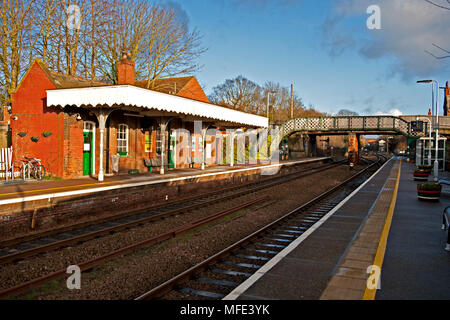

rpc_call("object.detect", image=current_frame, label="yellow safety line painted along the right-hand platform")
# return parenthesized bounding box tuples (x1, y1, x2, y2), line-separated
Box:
(362, 160, 402, 300)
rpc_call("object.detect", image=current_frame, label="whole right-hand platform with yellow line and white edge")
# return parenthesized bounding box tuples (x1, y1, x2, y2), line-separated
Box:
(225, 158, 450, 300)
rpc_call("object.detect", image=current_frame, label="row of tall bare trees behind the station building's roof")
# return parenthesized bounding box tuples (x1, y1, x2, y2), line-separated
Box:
(0, 0, 205, 105)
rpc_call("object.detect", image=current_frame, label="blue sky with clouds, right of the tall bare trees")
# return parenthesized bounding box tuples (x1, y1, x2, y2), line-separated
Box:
(162, 0, 450, 115)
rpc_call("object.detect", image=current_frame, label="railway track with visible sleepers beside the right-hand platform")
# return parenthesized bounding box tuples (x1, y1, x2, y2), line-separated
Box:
(137, 159, 382, 300)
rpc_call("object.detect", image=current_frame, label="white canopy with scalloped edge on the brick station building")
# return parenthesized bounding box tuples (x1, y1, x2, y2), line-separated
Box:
(47, 85, 269, 128)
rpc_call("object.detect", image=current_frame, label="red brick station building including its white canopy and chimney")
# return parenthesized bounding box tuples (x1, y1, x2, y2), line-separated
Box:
(11, 56, 268, 181)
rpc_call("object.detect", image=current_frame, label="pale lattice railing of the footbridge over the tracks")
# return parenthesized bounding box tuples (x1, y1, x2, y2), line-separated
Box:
(281, 116, 411, 137)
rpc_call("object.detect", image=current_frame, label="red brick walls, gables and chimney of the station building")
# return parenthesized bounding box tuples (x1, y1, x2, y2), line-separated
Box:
(11, 62, 223, 178)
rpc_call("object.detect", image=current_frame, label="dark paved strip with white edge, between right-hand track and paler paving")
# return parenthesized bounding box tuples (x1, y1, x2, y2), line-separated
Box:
(225, 161, 395, 300)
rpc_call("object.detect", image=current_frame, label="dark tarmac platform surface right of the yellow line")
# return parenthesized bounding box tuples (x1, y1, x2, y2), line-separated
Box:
(376, 163, 450, 300)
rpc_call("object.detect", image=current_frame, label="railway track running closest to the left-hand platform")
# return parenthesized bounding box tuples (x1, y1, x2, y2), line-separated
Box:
(0, 161, 343, 265)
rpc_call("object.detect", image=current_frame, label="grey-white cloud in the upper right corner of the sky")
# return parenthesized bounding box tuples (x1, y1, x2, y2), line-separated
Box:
(322, 0, 450, 79)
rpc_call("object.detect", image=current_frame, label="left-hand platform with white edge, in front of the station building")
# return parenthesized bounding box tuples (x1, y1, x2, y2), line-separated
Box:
(0, 157, 331, 237)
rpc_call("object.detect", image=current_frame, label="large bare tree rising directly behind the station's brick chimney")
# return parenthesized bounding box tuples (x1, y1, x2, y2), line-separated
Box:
(100, 0, 205, 85)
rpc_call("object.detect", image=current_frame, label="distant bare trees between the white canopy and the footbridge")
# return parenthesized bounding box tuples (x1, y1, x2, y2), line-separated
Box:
(208, 76, 323, 122)
